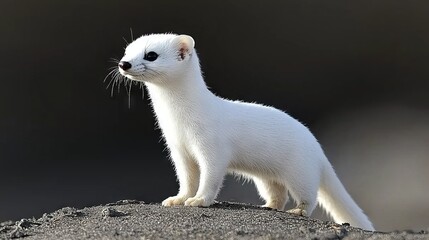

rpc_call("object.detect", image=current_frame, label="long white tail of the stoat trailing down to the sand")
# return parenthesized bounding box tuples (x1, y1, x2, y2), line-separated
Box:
(318, 162, 374, 231)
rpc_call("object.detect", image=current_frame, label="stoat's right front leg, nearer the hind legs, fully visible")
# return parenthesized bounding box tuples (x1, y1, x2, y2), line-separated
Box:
(185, 151, 228, 207)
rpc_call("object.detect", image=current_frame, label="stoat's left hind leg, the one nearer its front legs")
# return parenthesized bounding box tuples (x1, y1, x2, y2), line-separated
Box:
(253, 177, 288, 211)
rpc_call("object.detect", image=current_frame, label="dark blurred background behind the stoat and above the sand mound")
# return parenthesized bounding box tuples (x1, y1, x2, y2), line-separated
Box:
(0, 0, 429, 230)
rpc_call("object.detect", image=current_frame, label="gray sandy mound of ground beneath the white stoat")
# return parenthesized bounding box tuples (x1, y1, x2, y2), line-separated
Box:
(0, 200, 429, 240)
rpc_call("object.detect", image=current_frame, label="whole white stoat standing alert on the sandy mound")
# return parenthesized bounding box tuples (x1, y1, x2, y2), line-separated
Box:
(115, 34, 374, 230)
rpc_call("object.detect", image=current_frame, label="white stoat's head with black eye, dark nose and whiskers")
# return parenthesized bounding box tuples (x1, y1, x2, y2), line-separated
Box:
(118, 34, 195, 83)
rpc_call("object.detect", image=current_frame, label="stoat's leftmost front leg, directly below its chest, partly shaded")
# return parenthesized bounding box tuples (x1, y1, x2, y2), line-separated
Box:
(162, 149, 200, 206)
